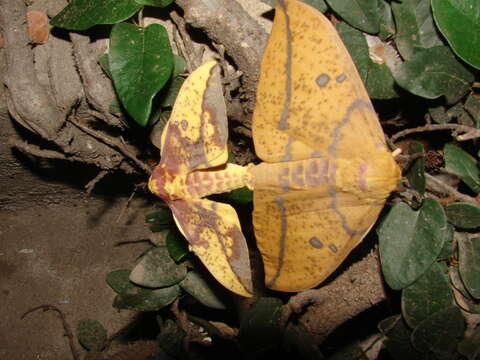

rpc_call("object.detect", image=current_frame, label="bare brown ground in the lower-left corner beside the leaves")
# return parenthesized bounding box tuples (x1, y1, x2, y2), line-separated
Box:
(0, 199, 156, 360)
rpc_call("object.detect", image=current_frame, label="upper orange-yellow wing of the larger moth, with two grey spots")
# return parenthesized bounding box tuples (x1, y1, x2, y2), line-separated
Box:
(253, 0, 385, 162)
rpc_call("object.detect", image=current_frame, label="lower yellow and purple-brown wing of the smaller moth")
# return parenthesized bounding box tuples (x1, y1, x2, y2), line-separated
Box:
(169, 199, 253, 297)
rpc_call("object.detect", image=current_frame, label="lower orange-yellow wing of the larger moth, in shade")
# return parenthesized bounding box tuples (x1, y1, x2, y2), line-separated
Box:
(253, 189, 383, 292)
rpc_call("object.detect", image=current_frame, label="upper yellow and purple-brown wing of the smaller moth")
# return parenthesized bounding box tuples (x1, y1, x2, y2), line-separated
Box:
(160, 61, 228, 174)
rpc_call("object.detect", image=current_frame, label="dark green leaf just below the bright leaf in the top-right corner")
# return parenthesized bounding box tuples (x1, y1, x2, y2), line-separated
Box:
(393, 46, 474, 104)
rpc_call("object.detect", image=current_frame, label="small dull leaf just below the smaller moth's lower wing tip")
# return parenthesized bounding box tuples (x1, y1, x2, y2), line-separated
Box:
(179, 271, 227, 309)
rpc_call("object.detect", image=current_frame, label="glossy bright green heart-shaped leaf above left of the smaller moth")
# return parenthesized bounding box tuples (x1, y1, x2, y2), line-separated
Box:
(108, 23, 173, 126)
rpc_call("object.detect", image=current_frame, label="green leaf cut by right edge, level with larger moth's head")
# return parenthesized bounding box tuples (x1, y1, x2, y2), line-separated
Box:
(443, 144, 480, 193)
